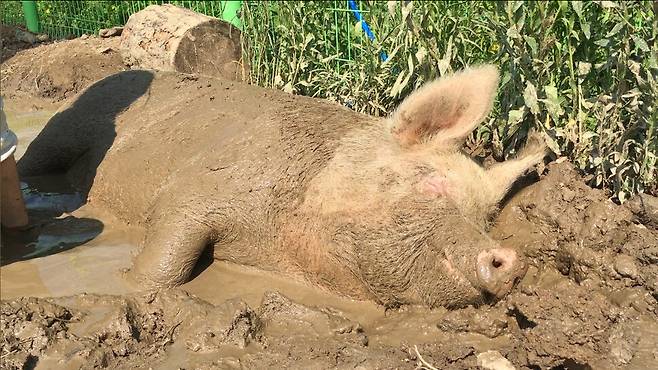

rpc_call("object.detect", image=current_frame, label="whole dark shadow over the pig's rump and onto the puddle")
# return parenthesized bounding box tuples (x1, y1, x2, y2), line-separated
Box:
(0, 71, 153, 265)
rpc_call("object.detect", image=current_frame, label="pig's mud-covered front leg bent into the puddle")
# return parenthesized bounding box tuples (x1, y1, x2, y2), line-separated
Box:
(130, 209, 213, 289)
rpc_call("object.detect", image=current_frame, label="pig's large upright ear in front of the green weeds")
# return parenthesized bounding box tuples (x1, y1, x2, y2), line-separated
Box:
(384, 65, 498, 147)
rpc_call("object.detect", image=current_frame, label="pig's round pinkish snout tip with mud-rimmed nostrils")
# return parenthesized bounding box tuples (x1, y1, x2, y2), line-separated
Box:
(477, 248, 528, 298)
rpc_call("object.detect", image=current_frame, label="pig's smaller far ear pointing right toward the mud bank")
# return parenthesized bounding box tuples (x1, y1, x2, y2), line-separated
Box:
(485, 134, 547, 206)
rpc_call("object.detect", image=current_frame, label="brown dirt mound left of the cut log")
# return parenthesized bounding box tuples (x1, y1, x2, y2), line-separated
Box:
(0, 37, 126, 102)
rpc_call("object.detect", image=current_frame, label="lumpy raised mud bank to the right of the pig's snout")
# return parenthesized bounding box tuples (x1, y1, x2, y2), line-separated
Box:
(491, 162, 658, 298)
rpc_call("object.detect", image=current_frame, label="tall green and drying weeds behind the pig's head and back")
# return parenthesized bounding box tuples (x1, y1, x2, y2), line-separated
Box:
(243, 1, 658, 202)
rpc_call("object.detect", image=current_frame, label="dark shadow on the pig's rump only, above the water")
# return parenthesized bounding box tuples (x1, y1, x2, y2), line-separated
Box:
(18, 71, 153, 199)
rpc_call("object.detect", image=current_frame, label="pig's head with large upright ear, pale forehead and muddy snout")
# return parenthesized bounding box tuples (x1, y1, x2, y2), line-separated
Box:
(307, 66, 527, 307)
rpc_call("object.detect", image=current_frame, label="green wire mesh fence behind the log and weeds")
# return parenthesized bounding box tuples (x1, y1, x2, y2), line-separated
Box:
(0, 0, 364, 72)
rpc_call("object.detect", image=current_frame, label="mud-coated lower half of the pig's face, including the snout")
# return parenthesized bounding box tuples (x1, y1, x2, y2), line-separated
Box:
(334, 194, 527, 307)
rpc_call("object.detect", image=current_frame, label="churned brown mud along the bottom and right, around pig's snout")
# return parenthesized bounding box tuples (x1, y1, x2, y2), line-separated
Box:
(0, 162, 658, 369)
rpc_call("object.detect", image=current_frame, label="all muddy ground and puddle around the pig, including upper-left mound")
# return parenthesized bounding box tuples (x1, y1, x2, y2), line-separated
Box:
(0, 38, 658, 369)
